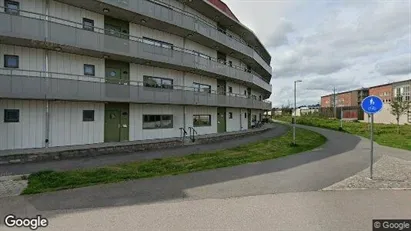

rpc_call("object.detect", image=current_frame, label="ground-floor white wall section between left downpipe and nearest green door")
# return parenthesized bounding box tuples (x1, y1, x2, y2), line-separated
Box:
(50, 101, 104, 146)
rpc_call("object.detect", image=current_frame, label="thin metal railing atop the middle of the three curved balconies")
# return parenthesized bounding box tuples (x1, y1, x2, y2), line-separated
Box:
(0, 7, 271, 92)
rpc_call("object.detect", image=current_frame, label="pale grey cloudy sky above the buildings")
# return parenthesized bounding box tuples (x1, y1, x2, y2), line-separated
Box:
(224, 0, 411, 107)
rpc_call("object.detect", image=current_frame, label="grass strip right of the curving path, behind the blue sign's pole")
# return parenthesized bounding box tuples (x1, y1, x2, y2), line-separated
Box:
(275, 116, 411, 150)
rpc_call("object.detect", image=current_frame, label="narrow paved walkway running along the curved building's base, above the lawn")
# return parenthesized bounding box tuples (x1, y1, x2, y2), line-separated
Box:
(0, 124, 288, 176)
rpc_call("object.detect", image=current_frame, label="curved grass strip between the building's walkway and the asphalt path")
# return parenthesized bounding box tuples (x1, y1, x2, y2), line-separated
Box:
(23, 129, 326, 194)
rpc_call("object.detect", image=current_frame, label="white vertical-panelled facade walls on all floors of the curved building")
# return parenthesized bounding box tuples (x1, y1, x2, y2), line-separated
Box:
(0, 0, 272, 150)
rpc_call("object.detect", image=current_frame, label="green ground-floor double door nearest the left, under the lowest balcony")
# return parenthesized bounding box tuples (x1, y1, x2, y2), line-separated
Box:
(104, 103, 129, 142)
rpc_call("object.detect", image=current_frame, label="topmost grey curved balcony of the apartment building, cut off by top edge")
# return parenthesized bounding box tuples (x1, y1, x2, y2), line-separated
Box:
(54, 0, 272, 78)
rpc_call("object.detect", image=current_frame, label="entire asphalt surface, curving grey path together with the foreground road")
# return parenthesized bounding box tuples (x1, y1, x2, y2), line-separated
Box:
(0, 126, 411, 230)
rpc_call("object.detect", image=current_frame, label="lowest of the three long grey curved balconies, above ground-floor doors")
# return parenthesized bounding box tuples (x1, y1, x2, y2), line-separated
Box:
(0, 69, 271, 110)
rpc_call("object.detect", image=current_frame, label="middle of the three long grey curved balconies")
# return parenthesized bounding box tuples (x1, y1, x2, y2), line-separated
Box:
(0, 11, 271, 97)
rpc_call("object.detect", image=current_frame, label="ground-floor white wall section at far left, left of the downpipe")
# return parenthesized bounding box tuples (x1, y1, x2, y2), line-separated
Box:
(0, 99, 46, 150)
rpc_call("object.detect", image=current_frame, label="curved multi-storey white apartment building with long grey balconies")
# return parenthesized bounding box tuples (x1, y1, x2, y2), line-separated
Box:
(0, 0, 272, 150)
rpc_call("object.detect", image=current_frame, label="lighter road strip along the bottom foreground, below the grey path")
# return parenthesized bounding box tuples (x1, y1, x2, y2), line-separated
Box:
(0, 190, 411, 231)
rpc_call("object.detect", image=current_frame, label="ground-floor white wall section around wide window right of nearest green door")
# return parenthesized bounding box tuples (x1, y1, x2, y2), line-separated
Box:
(129, 104, 184, 140)
